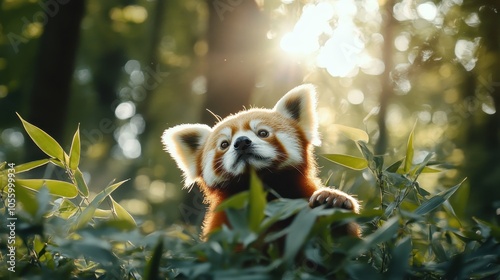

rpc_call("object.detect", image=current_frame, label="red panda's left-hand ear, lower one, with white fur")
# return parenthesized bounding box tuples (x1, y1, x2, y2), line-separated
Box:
(161, 124, 212, 187)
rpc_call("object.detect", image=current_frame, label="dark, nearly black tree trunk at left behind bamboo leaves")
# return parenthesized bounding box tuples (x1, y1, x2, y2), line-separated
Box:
(27, 0, 85, 160)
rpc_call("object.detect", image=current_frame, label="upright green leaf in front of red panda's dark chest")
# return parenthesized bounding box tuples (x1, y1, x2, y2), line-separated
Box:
(248, 169, 267, 232)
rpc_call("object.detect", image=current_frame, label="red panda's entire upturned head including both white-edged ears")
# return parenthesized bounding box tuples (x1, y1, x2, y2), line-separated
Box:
(162, 85, 319, 187)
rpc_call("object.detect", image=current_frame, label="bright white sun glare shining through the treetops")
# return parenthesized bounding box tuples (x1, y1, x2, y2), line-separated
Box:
(280, 0, 378, 77)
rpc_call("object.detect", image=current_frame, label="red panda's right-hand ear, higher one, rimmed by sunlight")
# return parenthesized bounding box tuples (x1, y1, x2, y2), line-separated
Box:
(274, 84, 321, 145)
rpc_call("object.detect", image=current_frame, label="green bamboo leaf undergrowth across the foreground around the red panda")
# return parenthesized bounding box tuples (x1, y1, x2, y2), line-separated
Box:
(0, 115, 500, 279)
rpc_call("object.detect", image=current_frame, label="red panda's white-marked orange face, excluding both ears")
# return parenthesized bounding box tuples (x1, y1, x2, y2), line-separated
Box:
(200, 109, 308, 186)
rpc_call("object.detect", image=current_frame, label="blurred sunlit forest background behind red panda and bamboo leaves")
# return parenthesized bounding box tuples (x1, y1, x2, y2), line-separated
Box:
(0, 0, 500, 231)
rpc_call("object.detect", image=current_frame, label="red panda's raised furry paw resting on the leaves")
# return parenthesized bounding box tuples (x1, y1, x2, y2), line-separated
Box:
(309, 188, 359, 213)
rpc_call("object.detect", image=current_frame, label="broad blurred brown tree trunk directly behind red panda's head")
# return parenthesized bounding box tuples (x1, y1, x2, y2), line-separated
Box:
(202, 0, 266, 124)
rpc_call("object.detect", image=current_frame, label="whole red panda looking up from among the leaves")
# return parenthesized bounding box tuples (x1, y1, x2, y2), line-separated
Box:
(162, 85, 360, 237)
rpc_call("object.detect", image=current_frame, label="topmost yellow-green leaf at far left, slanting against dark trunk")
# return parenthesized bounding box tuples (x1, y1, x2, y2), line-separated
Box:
(17, 114, 65, 162)
